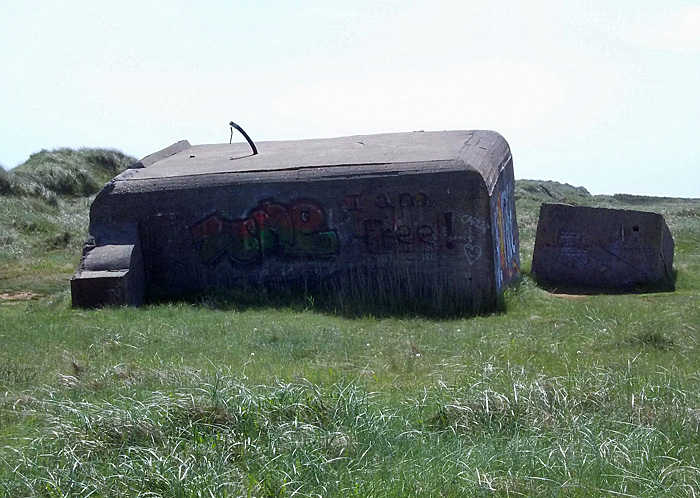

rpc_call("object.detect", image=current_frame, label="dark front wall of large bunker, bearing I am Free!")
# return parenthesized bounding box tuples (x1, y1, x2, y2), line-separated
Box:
(85, 164, 500, 313)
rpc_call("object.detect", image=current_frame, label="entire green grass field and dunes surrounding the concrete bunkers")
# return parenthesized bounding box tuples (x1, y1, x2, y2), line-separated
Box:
(0, 149, 700, 497)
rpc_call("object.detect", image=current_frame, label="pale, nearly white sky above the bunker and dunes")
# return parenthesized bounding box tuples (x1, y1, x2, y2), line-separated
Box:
(0, 0, 700, 197)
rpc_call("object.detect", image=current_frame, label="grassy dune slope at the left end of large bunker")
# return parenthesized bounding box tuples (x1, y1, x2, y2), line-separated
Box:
(0, 149, 136, 294)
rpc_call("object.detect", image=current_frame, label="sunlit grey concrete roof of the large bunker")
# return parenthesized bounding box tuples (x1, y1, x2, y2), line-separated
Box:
(116, 130, 511, 193)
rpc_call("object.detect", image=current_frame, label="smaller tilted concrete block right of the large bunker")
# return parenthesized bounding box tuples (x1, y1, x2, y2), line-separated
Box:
(532, 204, 674, 290)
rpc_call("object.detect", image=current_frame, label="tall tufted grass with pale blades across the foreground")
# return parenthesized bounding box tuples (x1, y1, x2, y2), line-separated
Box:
(5, 367, 700, 497)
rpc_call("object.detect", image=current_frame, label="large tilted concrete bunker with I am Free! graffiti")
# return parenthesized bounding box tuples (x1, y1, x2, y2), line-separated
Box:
(72, 131, 519, 314)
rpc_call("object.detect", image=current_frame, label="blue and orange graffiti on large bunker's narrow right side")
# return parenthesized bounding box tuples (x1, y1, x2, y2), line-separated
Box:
(492, 178, 520, 290)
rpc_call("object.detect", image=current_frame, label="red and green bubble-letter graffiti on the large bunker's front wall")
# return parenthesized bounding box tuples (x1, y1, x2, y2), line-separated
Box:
(190, 199, 339, 264)
